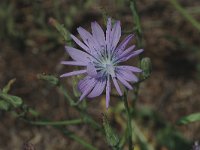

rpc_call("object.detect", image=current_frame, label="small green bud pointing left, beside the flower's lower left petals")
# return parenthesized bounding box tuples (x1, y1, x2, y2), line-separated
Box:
(37, 74, 59, 85)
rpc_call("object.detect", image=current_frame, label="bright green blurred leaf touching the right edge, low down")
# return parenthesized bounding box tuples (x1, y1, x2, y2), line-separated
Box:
(177, 113, 200, 124)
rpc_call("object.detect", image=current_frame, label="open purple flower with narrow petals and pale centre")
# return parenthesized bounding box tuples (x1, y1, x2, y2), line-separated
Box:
(61, 18, 143, 108)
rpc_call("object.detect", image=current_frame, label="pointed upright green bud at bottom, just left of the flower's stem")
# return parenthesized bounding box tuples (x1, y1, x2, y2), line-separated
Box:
(103, 114, 119, 149)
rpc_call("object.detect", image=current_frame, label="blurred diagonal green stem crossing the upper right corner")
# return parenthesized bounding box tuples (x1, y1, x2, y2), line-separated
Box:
(169, 0, 200, 31)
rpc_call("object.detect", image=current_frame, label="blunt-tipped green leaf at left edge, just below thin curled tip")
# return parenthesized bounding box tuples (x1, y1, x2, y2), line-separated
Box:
(0, 92, 23, 108)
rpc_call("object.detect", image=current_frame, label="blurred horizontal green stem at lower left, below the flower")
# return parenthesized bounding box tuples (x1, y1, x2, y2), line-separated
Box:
(29, 119, 83, 126)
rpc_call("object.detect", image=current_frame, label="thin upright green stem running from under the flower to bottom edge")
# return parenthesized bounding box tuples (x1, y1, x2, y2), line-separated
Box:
(123, 90, 133, 150)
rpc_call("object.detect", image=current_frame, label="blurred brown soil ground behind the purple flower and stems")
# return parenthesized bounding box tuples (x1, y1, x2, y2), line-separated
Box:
(0, 0, 200, 150)
